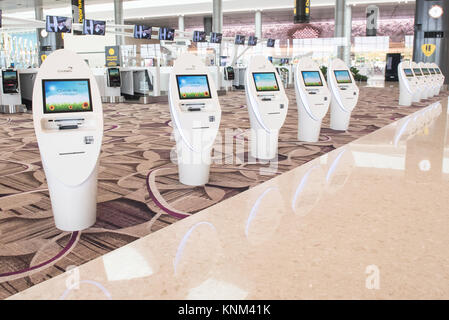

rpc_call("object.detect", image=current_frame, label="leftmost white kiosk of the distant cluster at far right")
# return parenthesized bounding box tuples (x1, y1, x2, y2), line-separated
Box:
(398, 61, 420, 106)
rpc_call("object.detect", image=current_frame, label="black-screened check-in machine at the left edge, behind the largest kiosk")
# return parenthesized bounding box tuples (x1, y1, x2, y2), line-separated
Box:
(0, 69, 27, 113)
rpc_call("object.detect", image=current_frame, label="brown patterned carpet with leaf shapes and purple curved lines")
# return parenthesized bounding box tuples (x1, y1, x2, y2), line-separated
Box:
(0, 88, 447, 298)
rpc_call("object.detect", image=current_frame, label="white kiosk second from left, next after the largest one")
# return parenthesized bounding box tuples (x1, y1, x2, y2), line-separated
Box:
(168, 54, 221, 186)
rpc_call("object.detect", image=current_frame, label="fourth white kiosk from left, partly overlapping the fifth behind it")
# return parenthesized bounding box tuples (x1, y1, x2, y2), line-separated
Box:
(295, 58, 331, 142)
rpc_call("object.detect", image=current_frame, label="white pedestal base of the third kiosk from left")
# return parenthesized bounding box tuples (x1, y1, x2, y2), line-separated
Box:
(251, 129, 279, 160)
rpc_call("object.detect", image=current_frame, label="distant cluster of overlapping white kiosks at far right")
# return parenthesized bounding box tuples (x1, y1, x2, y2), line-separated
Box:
(398, 61, 445, 106)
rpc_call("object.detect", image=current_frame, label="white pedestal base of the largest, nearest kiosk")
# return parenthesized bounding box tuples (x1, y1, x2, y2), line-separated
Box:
(44, 163, 98, 231)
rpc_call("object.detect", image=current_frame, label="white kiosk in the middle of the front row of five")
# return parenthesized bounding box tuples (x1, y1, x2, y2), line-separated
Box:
(245, 56, 288, 160)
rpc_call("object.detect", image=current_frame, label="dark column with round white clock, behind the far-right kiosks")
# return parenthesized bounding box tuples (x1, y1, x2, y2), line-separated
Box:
(413, 0, 449, 84)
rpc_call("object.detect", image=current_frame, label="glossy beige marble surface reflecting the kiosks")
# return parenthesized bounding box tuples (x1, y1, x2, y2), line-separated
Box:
(11, 100, 449, 299)
